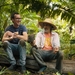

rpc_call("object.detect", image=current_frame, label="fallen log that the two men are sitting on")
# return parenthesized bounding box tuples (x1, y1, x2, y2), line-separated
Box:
(0, 48, 75, 74)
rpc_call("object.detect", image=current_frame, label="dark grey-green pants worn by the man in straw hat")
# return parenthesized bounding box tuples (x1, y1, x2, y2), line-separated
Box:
(31, 47, 63, 73)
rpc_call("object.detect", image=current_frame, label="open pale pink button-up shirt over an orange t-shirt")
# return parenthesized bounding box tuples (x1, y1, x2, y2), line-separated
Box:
(35, 31, 60, 48)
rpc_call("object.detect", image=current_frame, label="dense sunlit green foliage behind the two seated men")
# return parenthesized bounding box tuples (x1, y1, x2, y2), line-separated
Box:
(0, 0, 75, 58)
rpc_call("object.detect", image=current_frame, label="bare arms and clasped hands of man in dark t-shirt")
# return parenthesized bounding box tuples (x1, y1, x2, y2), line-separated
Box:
(2, 31, 28, 42)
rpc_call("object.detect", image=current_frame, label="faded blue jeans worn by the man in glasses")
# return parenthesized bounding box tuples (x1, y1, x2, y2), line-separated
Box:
(3, 40, 26, 66)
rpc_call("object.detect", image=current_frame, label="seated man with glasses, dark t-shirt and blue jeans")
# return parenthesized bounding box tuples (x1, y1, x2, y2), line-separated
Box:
(2, 13, 28, 73)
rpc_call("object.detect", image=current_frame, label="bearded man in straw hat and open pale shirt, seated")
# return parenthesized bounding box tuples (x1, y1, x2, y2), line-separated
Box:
(31, 18, 63, 73)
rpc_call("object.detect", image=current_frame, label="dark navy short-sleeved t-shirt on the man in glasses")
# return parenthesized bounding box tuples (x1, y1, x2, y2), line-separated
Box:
(5, 25, 27, 44)
